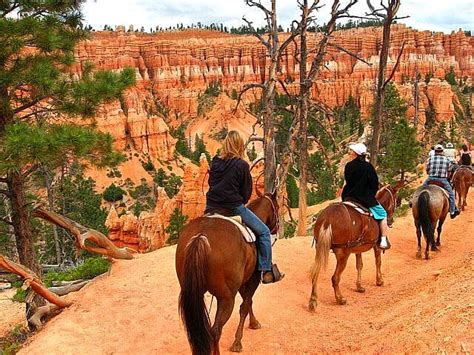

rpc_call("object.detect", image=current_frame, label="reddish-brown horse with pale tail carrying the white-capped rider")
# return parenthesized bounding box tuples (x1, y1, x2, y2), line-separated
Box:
(309, 182, 403, 312)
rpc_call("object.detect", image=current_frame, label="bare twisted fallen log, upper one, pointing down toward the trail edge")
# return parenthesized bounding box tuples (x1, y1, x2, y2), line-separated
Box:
(33, 207, 133, 260)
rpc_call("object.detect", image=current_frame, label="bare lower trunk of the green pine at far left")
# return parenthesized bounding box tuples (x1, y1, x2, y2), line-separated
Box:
(7, 171, 41, 276)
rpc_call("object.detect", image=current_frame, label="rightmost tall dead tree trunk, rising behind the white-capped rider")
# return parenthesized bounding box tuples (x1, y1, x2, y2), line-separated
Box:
(367, 0, 400, 166)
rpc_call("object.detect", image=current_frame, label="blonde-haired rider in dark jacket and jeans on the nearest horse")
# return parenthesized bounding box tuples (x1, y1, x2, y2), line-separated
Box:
(206, 131, 284, 283)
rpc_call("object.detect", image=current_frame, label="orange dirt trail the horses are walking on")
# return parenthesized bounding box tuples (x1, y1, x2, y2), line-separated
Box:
(21, 191, 474, 354)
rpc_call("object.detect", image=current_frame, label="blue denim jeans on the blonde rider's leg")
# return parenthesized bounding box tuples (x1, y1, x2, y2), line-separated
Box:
(234, 205, 272, 271)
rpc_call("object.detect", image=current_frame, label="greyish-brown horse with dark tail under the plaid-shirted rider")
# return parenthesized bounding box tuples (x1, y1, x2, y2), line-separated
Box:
(410, 185, 449, 260)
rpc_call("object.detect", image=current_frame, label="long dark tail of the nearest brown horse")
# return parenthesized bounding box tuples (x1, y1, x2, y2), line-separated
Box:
(179, 234, 213, 354)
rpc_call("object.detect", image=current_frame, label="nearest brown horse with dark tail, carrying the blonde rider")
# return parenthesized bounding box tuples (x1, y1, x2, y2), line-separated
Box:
(176, 193, 279, 354)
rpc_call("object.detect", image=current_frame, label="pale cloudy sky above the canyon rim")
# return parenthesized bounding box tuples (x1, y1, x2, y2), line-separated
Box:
(83, 0, 474, 33)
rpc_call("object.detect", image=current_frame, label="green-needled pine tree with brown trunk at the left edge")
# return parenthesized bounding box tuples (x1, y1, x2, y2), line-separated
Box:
(0, 0, 134, 272)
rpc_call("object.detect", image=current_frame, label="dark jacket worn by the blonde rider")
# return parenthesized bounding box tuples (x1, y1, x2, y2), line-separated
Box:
(206, 155, 252, 209)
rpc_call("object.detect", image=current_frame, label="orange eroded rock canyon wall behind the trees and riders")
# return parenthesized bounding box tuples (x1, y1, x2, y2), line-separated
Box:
(72, 24, 474, 251)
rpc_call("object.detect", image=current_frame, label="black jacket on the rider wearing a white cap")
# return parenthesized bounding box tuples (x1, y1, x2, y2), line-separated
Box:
(342, 157, 379, 208)
